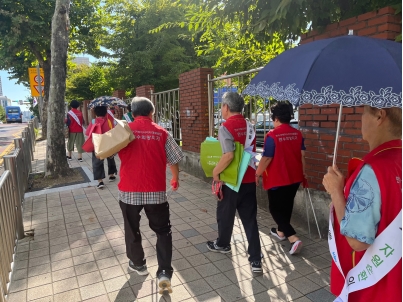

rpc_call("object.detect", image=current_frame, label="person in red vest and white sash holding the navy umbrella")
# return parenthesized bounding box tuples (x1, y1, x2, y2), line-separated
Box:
(323, 106, 402, 302)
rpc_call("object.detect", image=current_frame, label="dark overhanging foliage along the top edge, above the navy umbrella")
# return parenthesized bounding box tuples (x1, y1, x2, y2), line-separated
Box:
(188, 0, 401, 41)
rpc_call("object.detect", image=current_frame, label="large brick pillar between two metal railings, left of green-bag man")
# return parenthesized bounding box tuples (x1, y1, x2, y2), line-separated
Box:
(179, 68, 214, 153)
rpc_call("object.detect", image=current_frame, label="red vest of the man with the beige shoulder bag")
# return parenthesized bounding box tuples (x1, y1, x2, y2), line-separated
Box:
(118, 117, 168, 192)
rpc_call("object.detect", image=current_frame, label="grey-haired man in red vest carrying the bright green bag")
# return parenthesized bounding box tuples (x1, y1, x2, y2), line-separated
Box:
(207, 92, 262, 273)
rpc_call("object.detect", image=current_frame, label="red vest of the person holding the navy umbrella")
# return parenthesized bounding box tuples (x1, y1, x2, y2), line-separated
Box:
(330, 140, 402, 302)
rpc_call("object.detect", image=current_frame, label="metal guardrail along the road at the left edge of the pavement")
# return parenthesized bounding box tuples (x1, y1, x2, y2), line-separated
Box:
(0, 118, 38, 302)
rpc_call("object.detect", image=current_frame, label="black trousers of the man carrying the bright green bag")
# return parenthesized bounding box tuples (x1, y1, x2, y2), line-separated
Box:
(217, 183, 261, 262)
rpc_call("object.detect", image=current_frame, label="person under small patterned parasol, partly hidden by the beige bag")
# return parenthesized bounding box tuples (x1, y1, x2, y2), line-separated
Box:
(85, 106, 118, 189)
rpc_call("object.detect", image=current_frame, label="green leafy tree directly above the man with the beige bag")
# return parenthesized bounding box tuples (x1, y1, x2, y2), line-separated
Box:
(103, 0, 202, 95)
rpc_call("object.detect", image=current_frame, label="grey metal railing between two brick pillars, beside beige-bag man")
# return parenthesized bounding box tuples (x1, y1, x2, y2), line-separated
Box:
(151, 88, 182, 145)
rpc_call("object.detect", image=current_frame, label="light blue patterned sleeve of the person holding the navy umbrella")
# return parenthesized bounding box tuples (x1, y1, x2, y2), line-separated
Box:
(340, 165, 381, 244)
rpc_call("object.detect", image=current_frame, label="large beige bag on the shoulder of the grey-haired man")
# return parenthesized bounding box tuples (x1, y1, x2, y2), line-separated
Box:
(92, 119, 134, 159)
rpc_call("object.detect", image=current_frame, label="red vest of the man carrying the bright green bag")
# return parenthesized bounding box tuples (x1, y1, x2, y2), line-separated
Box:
(223, 114, 256, 183)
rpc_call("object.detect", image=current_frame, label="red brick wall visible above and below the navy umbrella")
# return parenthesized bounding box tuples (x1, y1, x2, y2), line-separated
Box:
(299, 7, 402, 191)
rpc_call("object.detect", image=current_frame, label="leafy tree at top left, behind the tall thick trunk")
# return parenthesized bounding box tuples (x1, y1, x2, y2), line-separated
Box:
(0, 0, 105, 136)
